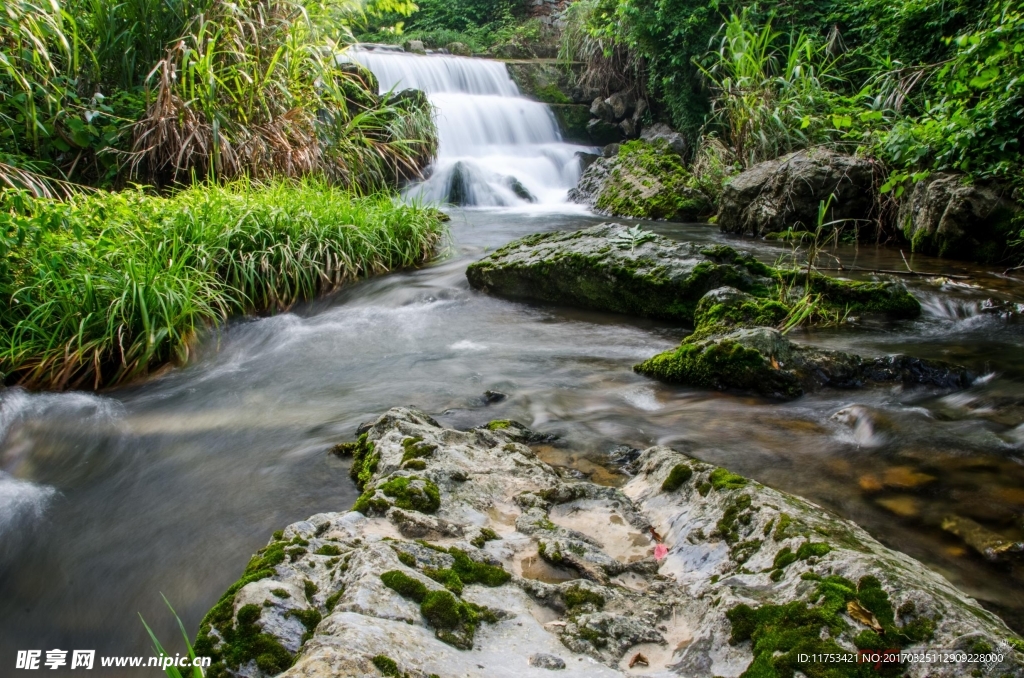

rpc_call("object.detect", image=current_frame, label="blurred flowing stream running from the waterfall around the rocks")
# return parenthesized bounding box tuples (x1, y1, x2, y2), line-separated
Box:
(6, 49, 1024, 676)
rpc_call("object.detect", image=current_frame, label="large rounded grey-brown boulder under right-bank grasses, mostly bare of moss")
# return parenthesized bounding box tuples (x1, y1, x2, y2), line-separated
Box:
(718, 149, 877, 236)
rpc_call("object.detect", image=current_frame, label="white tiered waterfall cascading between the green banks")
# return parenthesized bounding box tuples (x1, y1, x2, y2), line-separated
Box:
(349, 48, 590, 207)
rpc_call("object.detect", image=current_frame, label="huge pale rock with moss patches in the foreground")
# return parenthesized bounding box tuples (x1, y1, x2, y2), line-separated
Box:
(196, 408, 1024, 678)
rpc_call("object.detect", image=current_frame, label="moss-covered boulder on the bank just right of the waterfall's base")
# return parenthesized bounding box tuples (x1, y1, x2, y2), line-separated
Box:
(569, 137, 714, 221)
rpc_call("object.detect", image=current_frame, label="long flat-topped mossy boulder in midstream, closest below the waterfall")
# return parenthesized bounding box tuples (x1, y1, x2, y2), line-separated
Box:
(466, 223, 771, 323)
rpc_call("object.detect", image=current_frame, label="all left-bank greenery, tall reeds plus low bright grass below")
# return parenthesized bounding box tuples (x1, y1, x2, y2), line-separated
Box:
(0, 0, 442, 388)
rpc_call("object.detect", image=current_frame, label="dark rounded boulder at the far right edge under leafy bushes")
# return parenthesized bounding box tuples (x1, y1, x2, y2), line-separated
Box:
(899, 172, 1021, 262)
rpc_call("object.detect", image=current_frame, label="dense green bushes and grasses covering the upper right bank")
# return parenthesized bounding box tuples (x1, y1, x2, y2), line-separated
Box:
(562, 0, 1024, 246)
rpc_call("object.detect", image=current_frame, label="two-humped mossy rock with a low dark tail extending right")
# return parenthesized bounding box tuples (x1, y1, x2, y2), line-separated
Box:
(634, 288, 973, 398)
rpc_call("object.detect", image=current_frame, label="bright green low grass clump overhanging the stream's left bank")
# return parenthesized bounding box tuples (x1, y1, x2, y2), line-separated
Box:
(0, 180, 443, 389)
